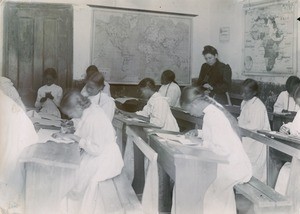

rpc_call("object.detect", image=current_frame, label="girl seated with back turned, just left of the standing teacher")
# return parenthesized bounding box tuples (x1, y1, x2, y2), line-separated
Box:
(158, 70, 181, 107)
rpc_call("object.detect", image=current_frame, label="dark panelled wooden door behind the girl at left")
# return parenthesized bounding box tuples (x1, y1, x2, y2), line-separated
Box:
(3, 3, 73, 105)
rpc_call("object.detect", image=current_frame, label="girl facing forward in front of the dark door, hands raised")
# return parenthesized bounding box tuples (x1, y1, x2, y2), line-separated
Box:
(35, 68, 63, 117)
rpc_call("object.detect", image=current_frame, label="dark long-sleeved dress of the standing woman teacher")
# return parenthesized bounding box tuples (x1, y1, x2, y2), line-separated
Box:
(197, 59, 232, 104)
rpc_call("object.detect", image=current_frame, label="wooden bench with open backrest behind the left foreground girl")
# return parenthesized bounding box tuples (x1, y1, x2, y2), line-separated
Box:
(95, 127, 158, 214)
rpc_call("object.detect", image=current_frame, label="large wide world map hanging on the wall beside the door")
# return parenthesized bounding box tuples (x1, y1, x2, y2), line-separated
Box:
(92, 8, 192, 84)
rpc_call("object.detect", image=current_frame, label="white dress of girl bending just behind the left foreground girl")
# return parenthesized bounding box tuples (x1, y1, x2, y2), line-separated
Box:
(82, 91, 116, 121)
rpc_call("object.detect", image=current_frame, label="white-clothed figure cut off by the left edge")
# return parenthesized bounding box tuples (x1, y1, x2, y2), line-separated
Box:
(0, 90, 38, 213)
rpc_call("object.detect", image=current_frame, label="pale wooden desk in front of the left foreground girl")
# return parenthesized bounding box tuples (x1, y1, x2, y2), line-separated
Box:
(20, 141, 80, 214)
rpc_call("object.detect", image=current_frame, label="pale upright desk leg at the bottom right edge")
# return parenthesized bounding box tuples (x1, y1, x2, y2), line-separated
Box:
(287, 157, 300, 213)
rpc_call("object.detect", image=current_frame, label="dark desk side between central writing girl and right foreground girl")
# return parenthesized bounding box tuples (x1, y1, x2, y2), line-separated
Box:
(171, 107, 203, 131)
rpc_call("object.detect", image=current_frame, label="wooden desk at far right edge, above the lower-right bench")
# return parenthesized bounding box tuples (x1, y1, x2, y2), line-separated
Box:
(241, 129, 300, 213)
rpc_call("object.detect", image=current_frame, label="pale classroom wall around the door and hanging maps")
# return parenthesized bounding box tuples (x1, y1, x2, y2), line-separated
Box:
(0, 0, 300, 84)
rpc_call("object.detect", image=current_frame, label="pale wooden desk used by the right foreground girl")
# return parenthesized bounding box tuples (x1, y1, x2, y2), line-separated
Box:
(149, 131, 227, 214)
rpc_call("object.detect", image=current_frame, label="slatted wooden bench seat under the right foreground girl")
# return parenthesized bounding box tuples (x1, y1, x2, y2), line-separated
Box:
(234, 173, 292, 214)
